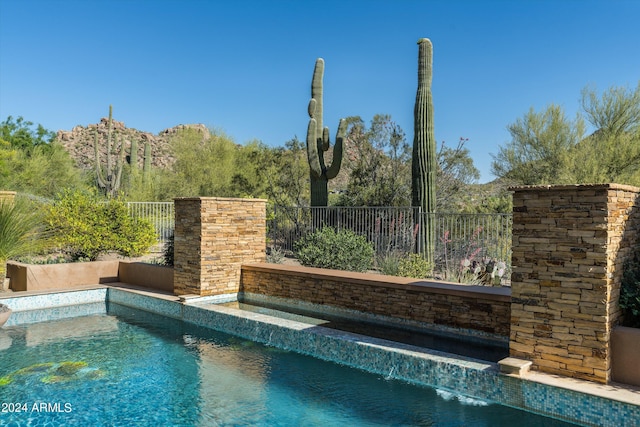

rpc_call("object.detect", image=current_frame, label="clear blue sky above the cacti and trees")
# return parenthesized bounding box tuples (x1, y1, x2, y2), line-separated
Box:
(0, 0, 640, 182)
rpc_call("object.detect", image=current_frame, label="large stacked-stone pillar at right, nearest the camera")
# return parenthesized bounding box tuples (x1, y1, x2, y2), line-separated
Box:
(510, 184, 640, 383)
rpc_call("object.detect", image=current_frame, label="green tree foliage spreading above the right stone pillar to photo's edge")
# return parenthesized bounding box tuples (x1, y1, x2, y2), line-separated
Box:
(492, 83, 640, 186)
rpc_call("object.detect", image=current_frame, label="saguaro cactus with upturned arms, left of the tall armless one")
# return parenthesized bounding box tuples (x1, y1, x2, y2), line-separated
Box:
(307, 58, 347, 206)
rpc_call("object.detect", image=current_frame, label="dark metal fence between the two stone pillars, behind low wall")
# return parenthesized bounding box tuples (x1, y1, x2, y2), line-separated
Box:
(267, 206, 512, 269)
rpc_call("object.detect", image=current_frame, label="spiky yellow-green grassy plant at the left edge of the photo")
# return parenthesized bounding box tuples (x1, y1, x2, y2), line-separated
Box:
(0, 197, 47, 286)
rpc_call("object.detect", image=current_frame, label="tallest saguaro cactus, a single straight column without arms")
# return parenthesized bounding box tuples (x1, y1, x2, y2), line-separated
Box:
(411, 39, 436, 265)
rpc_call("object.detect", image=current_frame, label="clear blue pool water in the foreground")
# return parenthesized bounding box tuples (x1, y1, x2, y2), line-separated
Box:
(0, 303, 572, 427)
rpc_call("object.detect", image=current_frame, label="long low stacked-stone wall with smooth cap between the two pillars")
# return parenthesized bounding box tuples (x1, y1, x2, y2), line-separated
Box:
(240, 264, 511, 337)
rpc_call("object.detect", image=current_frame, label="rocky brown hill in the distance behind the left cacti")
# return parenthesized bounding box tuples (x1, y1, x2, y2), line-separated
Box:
(56, 117, 210, 173)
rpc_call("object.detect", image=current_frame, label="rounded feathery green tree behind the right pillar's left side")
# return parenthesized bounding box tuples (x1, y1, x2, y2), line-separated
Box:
(491, 105, 584, 185)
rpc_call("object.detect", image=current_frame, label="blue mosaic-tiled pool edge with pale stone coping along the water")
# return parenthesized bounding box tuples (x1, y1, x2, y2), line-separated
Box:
(0, 286, 640, 427)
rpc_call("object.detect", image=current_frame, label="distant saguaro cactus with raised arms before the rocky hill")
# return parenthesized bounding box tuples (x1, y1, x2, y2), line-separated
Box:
(93, 105, 124, 197)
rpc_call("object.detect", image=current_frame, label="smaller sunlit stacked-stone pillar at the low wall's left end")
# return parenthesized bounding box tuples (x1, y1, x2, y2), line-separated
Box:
(174, 197, 266, 296)
